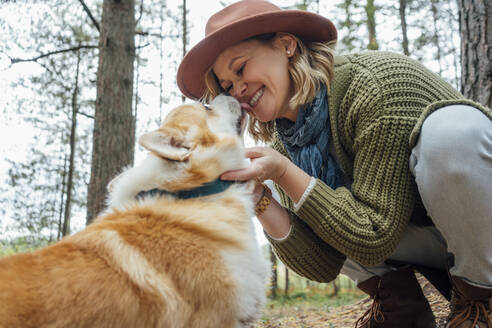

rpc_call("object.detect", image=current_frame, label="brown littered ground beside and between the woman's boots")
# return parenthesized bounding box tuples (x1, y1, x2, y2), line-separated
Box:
(254, 276, 448, 328)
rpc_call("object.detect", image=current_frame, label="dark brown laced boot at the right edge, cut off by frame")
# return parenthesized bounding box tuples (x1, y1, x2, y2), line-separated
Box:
(446, 276, 492, 328)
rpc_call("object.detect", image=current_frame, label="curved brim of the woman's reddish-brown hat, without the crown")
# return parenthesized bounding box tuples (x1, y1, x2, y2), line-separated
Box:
(177, 10, 337, 100)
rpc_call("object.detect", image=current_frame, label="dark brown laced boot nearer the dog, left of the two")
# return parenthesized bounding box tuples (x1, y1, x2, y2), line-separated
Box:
(355, 267, 436, 328)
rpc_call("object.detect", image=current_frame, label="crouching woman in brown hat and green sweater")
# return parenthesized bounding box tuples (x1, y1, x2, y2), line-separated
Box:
(177, 0, 492, 328)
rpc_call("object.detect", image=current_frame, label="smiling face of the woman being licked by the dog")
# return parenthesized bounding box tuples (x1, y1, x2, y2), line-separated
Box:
(213, 35, 297, 122)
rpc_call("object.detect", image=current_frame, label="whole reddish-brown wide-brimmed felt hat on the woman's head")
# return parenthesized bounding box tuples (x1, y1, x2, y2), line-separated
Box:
(177, 0, 337, 99)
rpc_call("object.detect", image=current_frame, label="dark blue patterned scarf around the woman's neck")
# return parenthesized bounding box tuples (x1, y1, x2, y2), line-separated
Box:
(276, 84, 343, 189)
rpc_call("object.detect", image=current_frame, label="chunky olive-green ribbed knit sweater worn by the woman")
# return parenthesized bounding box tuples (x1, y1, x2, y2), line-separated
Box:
(267, 52, 492, 281)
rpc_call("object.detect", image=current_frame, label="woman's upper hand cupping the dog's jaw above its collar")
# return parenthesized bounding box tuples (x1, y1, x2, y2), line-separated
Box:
(220, 147, 290, 182)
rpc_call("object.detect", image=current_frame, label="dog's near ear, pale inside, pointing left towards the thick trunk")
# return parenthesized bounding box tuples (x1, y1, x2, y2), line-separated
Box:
(138, 130, 193, 162)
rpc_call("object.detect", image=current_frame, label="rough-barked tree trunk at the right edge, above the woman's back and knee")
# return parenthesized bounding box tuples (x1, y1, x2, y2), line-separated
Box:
(458, 0, 492, 107)
